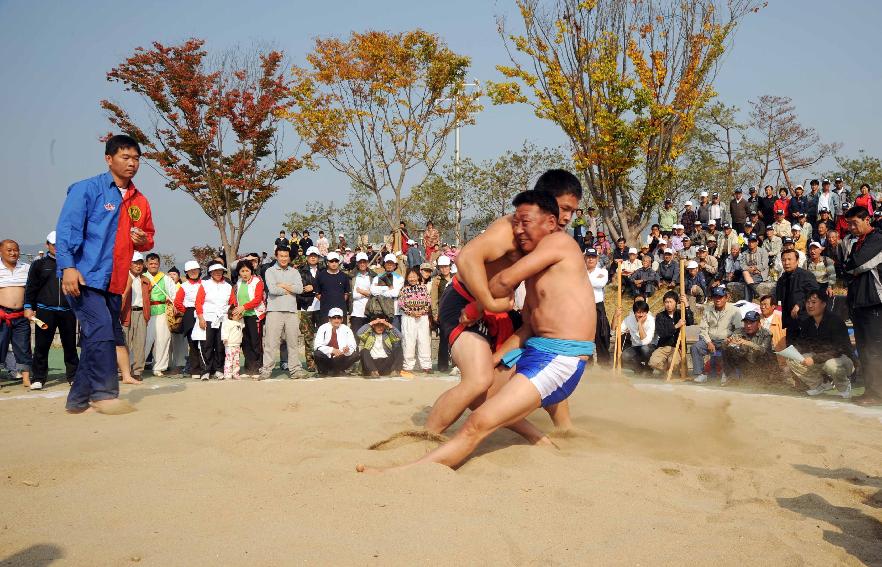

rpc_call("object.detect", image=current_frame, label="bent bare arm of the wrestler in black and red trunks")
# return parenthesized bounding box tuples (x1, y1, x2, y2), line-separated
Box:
(456, 216, 512, 312)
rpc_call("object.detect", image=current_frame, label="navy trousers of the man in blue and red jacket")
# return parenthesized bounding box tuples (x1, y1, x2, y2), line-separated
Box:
(66, 287, 126, 410)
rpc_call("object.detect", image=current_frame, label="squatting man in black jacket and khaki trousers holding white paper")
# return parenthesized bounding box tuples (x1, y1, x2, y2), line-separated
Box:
(787, 289, 854, 399)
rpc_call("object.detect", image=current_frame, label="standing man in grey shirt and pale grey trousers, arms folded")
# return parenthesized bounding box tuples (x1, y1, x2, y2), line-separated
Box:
(260, 248, 306, 379)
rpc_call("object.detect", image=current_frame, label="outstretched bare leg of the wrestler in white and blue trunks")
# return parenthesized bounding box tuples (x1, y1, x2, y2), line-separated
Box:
(356, 374, 541, 472)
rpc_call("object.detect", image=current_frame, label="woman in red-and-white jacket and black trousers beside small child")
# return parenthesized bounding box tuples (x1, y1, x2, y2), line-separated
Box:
(230, 259, 262, 378)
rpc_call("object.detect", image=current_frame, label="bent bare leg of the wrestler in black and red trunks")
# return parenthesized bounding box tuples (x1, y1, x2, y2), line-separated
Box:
(426, 332, 493, 434)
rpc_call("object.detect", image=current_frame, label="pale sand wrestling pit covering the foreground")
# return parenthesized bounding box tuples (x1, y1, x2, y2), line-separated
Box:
(0, 373, 882, 566)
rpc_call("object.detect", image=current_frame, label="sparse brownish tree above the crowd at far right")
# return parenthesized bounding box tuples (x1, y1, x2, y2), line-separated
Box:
(744, 95, 841, 187)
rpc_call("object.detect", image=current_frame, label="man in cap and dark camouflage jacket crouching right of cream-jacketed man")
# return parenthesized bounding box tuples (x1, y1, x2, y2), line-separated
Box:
(720, 311, 773, 386)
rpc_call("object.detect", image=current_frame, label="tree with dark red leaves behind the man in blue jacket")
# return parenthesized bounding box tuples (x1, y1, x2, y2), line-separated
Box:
(101, 39, 308, 258)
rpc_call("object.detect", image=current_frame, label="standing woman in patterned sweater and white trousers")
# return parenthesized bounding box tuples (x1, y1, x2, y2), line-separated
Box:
(398, 268, 432, 378)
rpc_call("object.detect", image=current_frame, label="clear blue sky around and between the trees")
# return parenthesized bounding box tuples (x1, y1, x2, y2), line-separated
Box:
(0, 0, 882, 263)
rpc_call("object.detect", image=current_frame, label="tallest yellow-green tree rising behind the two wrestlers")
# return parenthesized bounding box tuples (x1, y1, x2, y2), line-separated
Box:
(489, 0, 756, 242)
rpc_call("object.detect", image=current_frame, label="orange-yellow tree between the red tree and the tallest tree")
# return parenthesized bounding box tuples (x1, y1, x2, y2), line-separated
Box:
(280, 30, 480, 234)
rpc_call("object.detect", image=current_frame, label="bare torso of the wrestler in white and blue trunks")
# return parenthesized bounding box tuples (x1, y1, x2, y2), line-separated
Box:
(525, 233, 597, 341)
